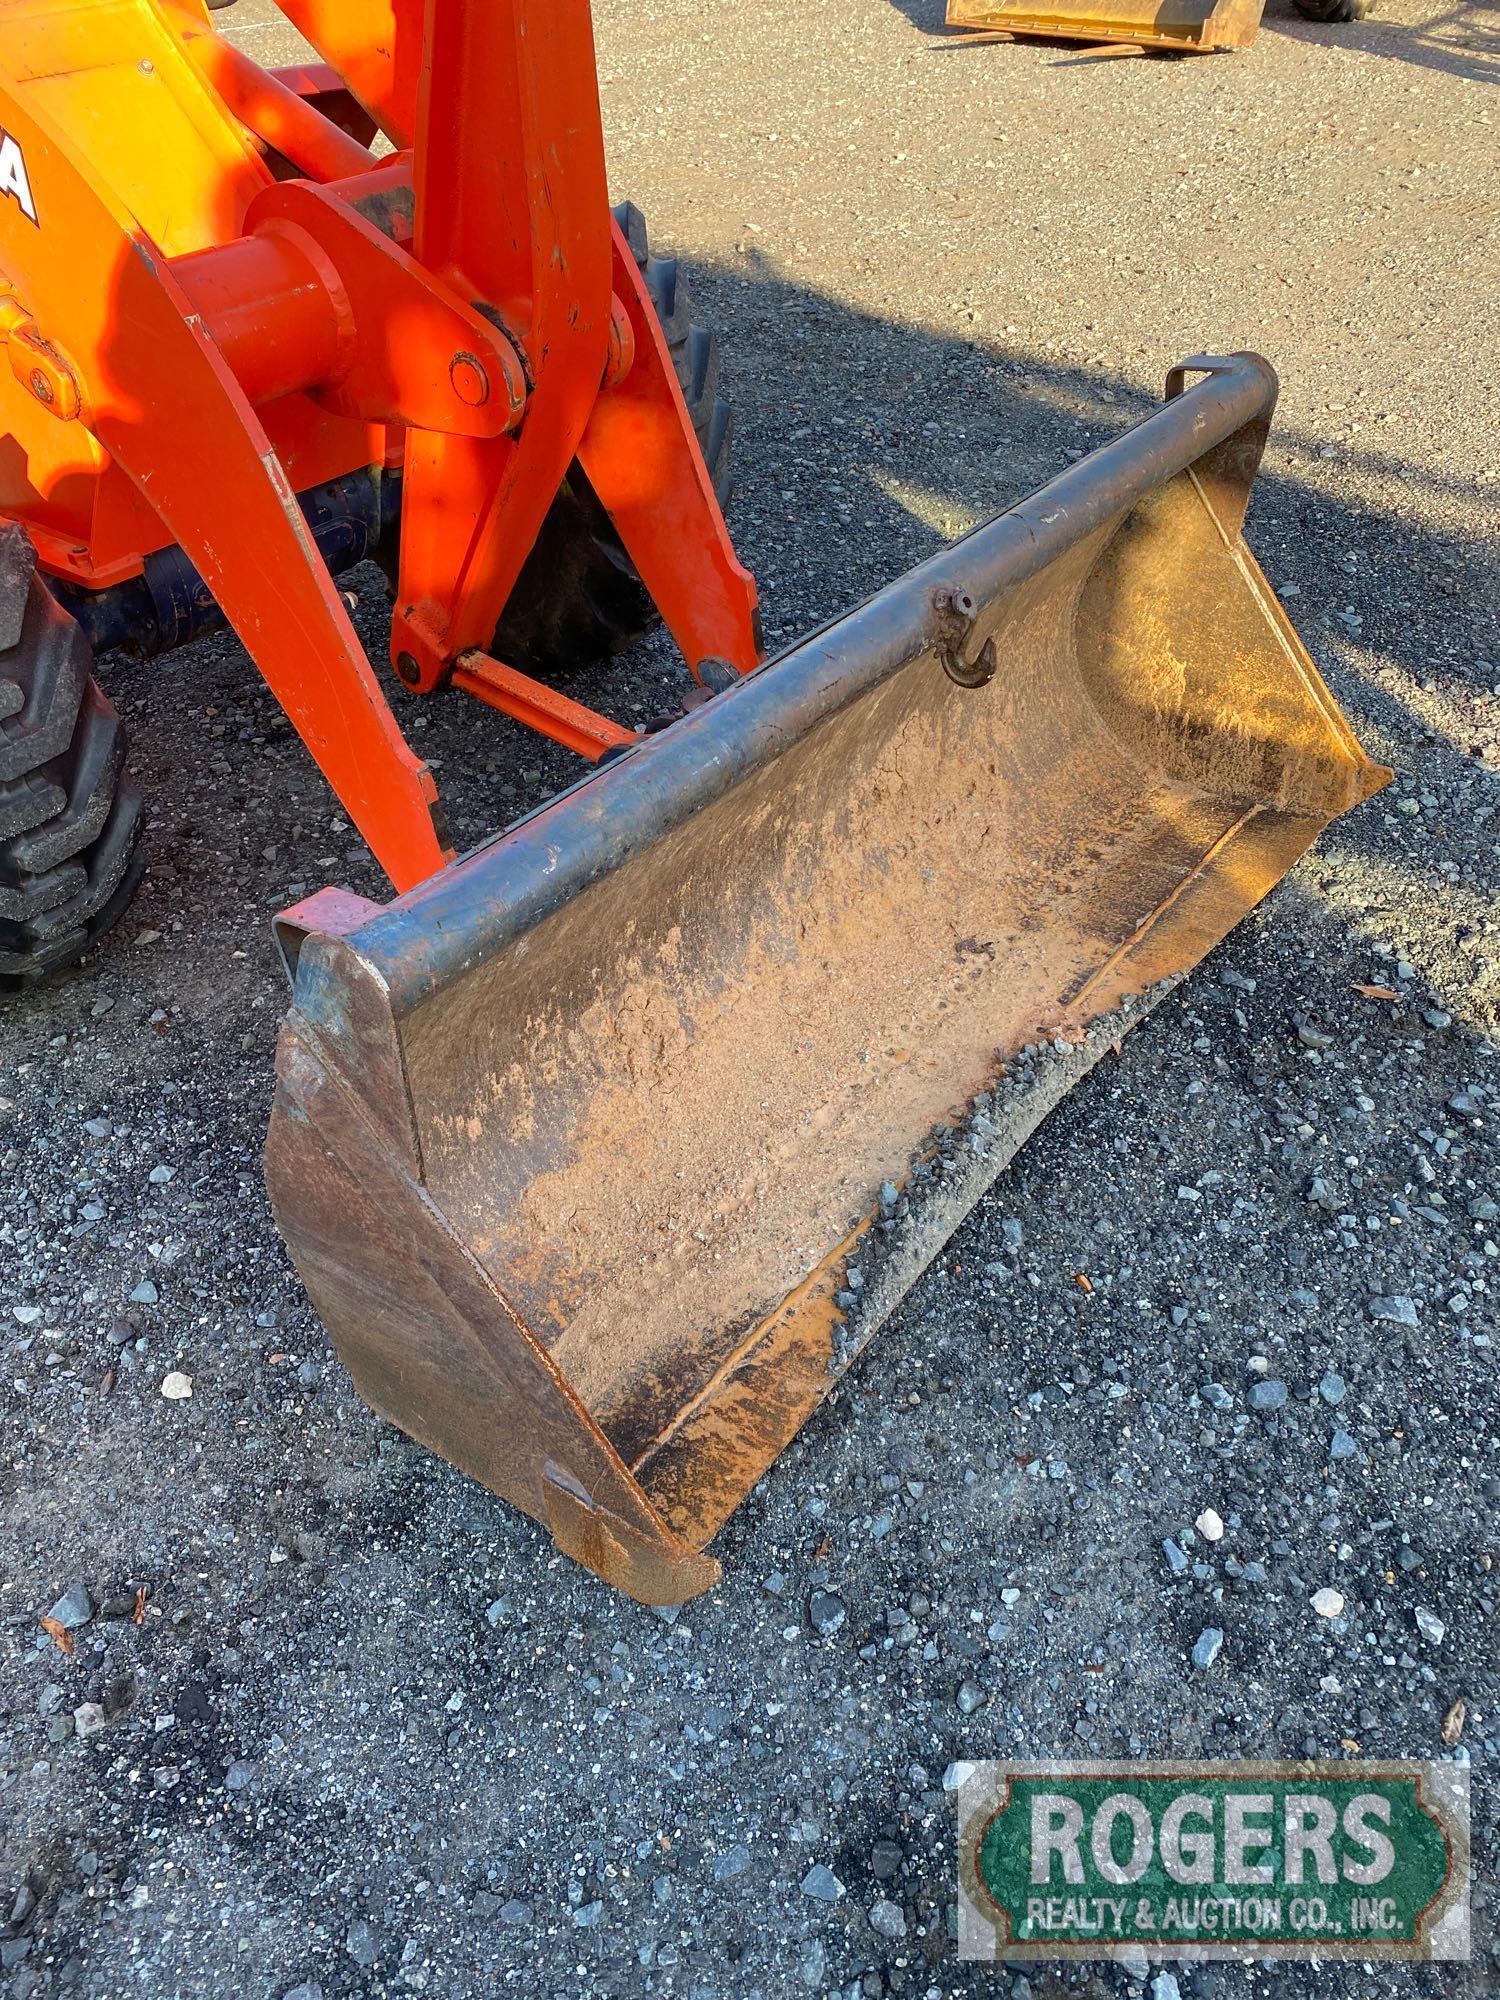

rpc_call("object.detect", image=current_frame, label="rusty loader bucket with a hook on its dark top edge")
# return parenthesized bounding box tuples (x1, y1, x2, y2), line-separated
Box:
(266, 356, 1388, 1604)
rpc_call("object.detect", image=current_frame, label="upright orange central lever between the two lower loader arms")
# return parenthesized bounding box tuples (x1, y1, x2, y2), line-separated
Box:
(390, 0, 624, 688)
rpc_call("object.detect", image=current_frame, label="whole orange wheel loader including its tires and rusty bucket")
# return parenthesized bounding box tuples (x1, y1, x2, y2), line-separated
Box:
(0, 0, 1384, 1604)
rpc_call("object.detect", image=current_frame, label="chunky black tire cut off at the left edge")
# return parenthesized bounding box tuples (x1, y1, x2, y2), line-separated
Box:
(0, 524, 142, 990)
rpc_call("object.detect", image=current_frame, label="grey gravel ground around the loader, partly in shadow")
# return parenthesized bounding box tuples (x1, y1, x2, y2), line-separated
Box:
(0, 0, 1500, 2000)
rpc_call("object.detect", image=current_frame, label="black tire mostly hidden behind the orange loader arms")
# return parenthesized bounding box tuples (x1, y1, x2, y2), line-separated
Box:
(494, 202, 730, 678)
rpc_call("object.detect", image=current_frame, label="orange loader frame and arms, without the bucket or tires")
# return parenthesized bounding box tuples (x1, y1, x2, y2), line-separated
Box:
(0, 0, 760, 890)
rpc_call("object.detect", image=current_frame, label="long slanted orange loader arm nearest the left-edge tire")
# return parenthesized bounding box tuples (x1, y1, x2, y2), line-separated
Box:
(0, 70, 450, 888)
